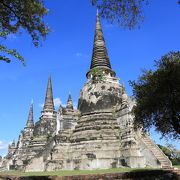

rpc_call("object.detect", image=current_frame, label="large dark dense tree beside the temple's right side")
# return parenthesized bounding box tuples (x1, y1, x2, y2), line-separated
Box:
(130, 52, 180, 139)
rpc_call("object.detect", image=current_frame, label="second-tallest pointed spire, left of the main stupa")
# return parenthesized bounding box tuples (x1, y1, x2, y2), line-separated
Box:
(43, 76, 55, 111)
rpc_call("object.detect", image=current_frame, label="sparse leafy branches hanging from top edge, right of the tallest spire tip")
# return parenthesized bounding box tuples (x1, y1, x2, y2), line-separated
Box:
(91, 0, 147, 29)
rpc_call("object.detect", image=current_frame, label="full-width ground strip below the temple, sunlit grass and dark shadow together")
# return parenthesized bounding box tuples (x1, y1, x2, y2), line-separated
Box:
(0, 168, 180, 180)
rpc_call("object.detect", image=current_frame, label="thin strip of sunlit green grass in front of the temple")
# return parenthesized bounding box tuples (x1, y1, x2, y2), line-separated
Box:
(0, 168, 160, 176)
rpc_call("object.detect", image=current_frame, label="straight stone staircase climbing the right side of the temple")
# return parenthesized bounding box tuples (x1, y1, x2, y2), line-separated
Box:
(142, 133, 172, 169)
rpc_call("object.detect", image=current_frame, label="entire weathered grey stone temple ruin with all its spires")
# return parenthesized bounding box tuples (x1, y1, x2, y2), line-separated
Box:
(0, 10, 172, 172)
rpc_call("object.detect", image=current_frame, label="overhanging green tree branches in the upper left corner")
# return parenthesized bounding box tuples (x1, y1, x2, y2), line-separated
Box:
(0, 0, 49, 64)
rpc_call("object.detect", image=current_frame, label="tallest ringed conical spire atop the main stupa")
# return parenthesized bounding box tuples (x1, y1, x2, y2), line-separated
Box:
(90, 9, 111, 69)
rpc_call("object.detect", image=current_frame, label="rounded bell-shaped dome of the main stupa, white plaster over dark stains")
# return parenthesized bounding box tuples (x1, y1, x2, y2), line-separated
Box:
(78, 76, 122, 114)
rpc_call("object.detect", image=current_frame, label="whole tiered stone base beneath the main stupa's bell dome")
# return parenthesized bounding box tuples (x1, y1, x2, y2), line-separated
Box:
(46, 113, 121, 170)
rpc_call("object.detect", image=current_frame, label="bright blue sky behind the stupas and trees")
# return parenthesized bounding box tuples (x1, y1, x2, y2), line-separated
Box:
(0, 0, 180, 155)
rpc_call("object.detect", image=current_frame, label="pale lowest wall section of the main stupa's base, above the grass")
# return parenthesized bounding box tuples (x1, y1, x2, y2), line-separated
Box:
(46, 140, 121, 171)
